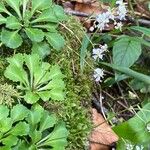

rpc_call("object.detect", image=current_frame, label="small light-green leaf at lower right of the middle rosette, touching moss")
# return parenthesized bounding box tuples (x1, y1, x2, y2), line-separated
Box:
(50, 89, 65, 100)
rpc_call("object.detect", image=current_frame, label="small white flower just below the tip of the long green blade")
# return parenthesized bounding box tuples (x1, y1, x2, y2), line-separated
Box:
(93, 68, 104, 82)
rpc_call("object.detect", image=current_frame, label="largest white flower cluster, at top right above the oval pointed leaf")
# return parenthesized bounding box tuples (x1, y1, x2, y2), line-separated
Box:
(89, 0, 127, 31)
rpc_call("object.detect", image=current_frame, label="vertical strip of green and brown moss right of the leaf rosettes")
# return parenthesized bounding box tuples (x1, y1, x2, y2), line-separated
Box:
(47, 18, 93, 150)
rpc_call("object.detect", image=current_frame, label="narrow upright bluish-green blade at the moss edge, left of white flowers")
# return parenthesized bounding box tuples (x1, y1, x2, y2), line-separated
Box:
(80, 35, 90, 72)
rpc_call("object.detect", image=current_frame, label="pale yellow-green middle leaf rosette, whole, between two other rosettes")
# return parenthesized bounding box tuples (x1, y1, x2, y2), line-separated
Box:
(4, 54, 65, 104)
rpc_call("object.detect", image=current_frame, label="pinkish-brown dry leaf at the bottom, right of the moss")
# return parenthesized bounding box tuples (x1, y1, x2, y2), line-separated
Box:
(89, 109, 118, 150)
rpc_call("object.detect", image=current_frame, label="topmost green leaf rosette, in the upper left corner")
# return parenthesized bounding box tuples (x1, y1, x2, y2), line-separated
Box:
(0, 0, 66, 50)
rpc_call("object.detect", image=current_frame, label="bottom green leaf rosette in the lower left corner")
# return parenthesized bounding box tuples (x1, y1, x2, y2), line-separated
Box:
(0, 104, 68, 150)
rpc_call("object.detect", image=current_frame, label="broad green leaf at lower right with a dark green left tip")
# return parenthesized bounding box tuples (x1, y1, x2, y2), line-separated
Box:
(114, 103, 150, 144)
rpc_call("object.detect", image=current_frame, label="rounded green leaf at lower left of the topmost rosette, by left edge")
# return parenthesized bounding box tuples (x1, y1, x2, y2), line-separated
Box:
(1, 30, 23, 49)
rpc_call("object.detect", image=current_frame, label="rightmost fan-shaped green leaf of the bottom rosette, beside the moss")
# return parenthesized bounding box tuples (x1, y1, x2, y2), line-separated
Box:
(40, 122, 68, 150)
